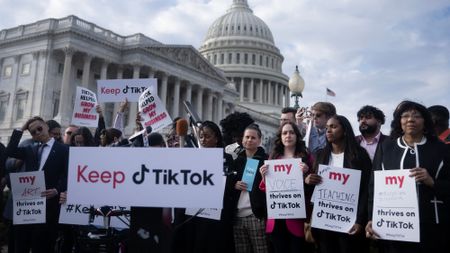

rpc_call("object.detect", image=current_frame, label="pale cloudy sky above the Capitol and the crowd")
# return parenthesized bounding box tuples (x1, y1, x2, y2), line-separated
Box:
(0, 0, 450, 133)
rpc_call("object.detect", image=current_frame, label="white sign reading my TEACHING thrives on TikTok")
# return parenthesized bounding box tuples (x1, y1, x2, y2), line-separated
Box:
(311, 165, 361, 233)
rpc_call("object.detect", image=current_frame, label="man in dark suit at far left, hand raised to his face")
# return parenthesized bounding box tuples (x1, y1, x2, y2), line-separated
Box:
(6, 117, 69, 253)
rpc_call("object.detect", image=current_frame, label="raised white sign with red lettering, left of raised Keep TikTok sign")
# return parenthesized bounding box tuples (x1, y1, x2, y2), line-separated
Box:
(72, 87, 98, 127)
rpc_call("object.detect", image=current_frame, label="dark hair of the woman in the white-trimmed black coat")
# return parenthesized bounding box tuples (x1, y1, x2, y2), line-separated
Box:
(391, 100, 436, 139)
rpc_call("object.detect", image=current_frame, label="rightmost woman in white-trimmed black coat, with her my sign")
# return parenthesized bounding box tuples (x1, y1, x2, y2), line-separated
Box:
(366, 101, 450, 253)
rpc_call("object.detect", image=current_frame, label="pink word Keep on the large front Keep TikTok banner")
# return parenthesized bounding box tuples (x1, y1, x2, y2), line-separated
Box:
(77, 165, 125, 189)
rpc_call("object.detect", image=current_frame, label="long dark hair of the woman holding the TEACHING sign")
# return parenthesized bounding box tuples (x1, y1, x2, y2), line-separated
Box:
(324, 115, 361, 161)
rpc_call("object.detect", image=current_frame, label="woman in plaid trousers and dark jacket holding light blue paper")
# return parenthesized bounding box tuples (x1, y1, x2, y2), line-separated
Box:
(227, 124, 268, 253)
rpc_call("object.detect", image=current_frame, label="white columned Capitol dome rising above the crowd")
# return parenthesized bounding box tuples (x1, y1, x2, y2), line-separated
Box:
(199, 0, 289, 113)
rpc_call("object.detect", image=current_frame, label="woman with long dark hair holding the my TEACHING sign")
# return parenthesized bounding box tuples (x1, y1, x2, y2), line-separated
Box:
(305, 115, 372, 253)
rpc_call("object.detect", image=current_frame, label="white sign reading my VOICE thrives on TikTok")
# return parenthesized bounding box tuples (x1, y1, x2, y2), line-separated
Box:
(265, 159, 306, 219)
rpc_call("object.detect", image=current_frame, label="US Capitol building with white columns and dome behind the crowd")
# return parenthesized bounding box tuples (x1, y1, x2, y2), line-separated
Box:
(0, 0, 289, 146)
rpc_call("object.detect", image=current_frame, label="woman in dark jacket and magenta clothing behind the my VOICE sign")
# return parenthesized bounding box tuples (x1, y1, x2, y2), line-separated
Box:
(259, 122, 312, 253)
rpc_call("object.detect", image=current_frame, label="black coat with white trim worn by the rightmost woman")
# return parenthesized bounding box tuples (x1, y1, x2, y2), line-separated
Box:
(369, 138, 450, 253)
